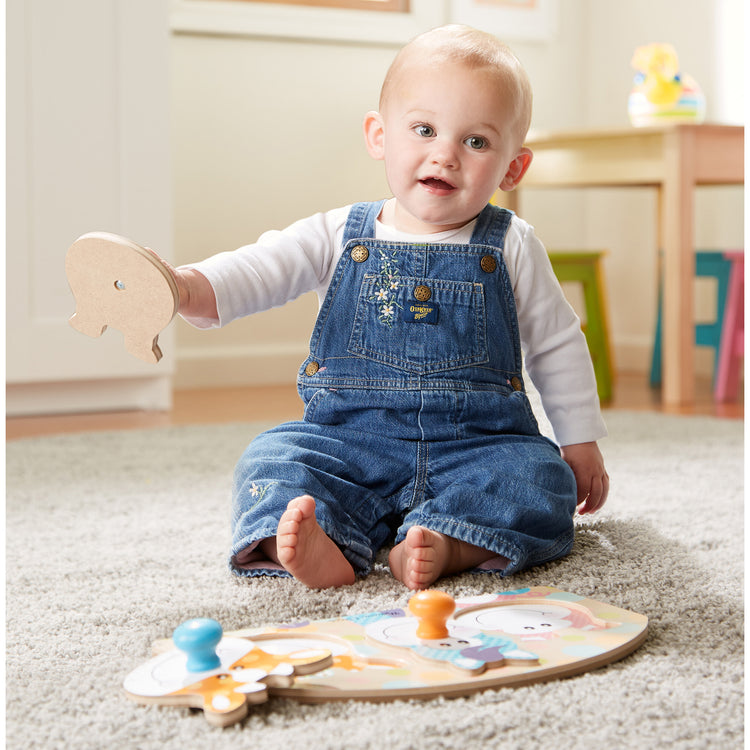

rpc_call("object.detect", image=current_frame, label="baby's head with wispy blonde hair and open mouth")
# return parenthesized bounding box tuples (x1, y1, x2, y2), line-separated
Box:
(364, 26, 532, 234)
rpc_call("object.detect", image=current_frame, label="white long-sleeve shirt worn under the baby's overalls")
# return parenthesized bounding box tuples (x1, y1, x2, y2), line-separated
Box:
(185, 200, 607, 445)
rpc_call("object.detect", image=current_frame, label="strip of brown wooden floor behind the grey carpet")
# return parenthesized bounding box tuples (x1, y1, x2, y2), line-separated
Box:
(5, 373, 745, 440)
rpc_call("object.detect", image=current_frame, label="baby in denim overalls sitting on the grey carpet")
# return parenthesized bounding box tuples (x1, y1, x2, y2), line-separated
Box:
(173, 26, 609, 589)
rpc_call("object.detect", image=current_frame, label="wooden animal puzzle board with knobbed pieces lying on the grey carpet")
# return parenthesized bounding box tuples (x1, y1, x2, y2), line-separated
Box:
(125, 586, 648, 726)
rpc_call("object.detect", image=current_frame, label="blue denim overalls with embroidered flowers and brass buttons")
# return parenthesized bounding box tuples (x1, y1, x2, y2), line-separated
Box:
(230, 203, 576, 575)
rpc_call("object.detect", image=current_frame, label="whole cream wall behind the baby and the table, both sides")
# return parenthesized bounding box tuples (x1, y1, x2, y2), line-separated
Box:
(171, 0, 743, 386)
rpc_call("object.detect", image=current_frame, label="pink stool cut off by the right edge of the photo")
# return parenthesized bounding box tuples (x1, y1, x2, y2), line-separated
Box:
(714, 250, 745, 402)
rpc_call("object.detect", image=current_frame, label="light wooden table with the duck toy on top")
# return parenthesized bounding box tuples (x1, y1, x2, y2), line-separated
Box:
(497, 124, 744, 405)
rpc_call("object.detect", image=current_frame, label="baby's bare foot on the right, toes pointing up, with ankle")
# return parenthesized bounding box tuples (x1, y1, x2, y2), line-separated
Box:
(388, 526, 496, 590)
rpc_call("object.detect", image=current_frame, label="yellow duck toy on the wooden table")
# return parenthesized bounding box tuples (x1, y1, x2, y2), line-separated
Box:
(628, 44, 706, 127)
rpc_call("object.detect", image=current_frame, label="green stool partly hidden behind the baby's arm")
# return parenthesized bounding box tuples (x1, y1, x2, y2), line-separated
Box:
(549, 250, 612, 402)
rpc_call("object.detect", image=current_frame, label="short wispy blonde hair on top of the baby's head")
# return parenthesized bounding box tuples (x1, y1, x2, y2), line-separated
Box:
(380, 24, 532, 142)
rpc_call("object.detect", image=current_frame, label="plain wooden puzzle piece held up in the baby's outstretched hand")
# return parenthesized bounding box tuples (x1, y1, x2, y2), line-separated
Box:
(65, 232, 179, 363)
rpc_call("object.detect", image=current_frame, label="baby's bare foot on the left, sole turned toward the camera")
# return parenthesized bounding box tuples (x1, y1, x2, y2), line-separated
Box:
(276, 495, 355, 588)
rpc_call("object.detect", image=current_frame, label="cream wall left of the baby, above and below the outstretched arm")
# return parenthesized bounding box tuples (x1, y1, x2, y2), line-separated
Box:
(172, 31, 392, 385)
